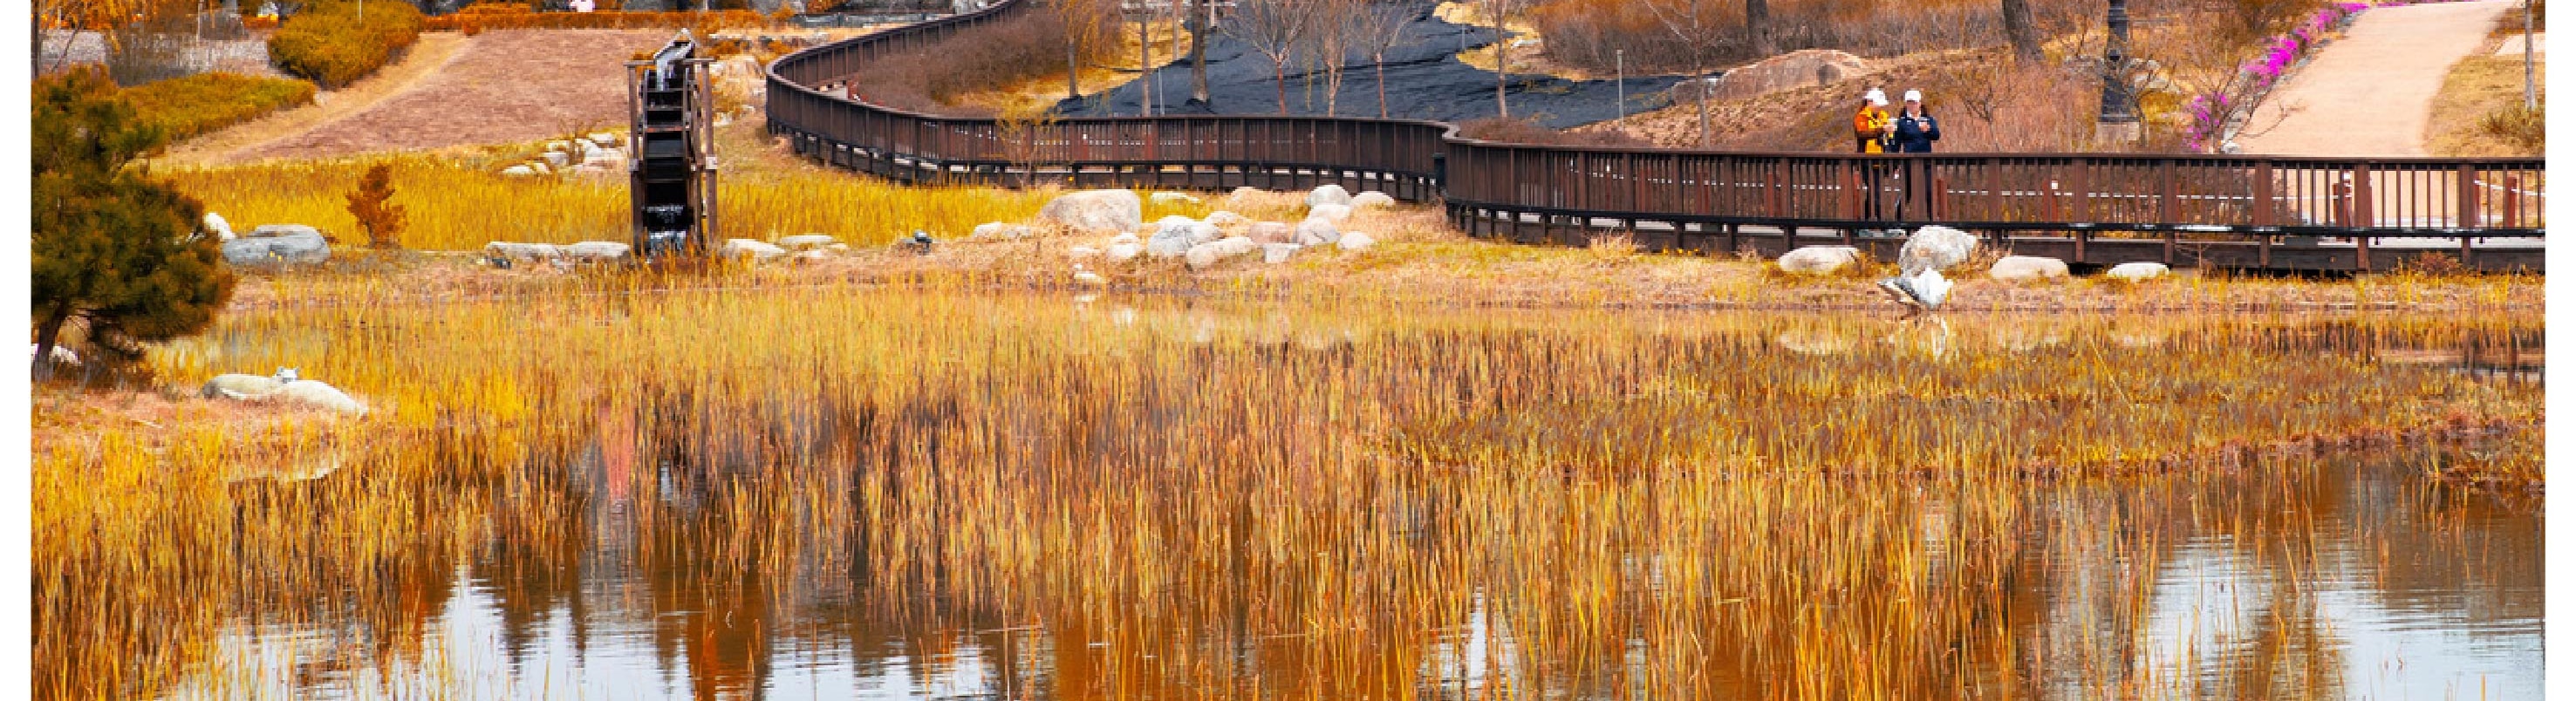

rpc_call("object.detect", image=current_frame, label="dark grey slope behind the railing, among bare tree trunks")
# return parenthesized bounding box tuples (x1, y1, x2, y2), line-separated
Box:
(1059, 3, 1682, 129)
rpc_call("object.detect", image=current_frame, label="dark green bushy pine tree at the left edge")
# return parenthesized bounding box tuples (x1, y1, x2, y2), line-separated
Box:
(28, 70, 232, 377)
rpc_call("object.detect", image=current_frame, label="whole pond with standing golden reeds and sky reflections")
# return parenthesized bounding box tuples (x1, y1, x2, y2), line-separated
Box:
(95, 296, 2545, 698)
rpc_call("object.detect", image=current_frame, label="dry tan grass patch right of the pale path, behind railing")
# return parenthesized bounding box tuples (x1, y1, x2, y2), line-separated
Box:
(2424, 51, 2548, 157)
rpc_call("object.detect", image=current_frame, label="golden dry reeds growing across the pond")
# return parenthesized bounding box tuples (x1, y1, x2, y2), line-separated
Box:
(33, 283, 2543, 698)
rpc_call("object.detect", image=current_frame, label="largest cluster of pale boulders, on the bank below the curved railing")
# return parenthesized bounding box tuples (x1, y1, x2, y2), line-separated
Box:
(1015, 186, 1397, 286)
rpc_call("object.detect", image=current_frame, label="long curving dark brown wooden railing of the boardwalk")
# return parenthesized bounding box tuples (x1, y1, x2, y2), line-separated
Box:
(768, 0, 2545, 270)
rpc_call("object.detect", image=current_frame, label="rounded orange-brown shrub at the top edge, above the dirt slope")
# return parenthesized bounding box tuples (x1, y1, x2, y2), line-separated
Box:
(268, 3, 422, 88)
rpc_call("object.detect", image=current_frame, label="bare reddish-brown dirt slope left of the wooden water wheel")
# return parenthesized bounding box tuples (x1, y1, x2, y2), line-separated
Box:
(170, 29, 670, 162)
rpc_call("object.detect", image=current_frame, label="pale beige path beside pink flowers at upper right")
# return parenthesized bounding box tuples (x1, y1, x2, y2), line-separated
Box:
(2236, 0, 2517, 157)
